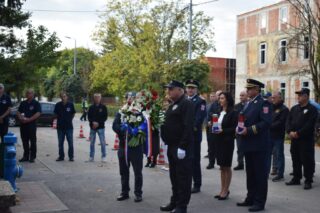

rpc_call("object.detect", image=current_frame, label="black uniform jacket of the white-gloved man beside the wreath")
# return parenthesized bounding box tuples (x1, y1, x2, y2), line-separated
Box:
(161, 96, 195, 150)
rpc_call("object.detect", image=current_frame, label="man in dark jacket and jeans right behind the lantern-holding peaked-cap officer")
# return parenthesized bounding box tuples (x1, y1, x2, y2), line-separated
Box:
(270, 92, 289, 182)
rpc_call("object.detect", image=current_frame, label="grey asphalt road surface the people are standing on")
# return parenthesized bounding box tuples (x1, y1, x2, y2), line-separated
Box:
(10, 117, 320, 213)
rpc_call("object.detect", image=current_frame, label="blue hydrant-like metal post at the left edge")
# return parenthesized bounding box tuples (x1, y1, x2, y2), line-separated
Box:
(4, 132, 23, 192)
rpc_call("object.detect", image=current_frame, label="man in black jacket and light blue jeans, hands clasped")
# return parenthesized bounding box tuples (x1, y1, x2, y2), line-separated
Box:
(88, 93, 108, 162)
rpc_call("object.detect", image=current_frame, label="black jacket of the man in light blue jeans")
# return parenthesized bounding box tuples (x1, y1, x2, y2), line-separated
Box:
(88, 104, 108, 129)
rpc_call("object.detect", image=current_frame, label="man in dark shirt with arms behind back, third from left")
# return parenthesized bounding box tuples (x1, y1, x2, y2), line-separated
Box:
(54, 92, 76, 161)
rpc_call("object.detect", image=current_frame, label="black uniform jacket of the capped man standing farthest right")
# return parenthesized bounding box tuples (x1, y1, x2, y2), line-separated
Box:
(286, 103, 318, 142)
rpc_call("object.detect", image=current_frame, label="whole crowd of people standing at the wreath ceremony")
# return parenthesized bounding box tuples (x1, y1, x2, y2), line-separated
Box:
(0, 79, 318, 213)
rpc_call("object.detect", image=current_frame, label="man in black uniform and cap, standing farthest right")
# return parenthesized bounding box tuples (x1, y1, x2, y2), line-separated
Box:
(286, 88, 318, 190)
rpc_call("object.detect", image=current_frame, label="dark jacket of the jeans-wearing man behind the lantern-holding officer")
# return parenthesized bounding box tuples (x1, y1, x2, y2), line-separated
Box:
(270, 102, 289, 140)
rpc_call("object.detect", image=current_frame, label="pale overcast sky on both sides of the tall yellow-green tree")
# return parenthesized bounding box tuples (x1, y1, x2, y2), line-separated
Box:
(23, 0, 279, 58)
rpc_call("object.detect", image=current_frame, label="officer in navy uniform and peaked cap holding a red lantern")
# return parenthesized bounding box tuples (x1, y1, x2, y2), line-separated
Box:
(237, 79, 272, 212)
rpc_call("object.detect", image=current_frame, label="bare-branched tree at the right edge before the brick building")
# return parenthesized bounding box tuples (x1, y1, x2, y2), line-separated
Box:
(287, 0, 320, 102)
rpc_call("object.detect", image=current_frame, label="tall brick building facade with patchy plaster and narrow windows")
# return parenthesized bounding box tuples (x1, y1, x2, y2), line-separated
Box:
(236, 1, 314, 106)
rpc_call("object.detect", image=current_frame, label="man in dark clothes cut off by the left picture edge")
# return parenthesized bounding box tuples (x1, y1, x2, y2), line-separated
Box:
(0, 84, 12, 142)
